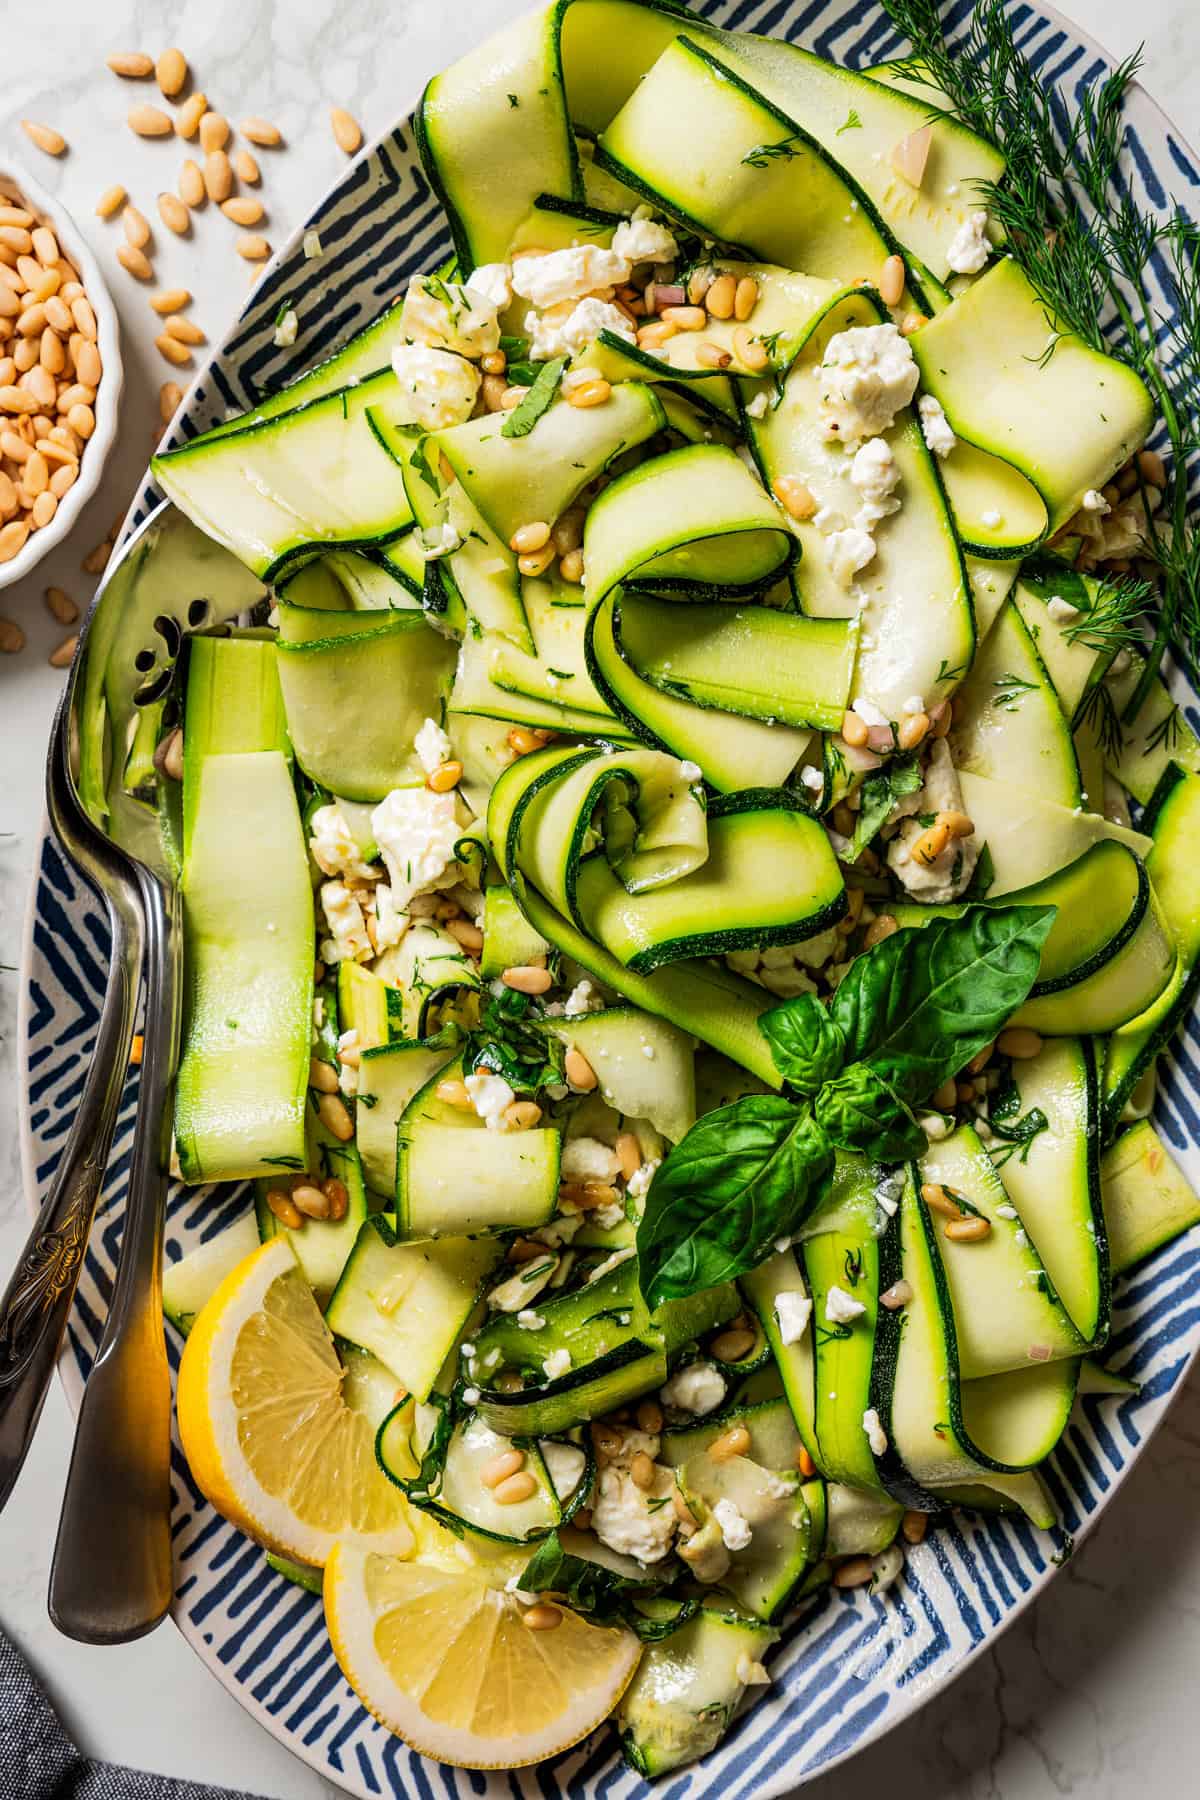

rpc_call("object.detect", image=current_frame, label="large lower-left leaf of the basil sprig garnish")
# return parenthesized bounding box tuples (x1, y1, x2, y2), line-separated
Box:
(637, 1094, 833, 1309)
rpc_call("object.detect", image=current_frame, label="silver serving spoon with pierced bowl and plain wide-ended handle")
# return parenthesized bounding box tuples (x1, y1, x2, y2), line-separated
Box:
(2, 506, 264, 1643)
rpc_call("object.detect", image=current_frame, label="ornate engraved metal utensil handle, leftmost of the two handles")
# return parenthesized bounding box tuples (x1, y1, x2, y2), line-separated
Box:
(0, 895, 142, 1508)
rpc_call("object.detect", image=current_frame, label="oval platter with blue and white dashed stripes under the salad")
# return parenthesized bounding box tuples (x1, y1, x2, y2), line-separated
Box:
(20, 0, 1200, 1800)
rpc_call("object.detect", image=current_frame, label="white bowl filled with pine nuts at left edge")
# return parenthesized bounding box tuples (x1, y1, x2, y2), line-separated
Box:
(0, 162, 122, 589)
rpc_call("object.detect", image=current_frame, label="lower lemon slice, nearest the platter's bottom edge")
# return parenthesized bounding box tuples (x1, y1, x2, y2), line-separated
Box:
(324, 1543, 640, 1769)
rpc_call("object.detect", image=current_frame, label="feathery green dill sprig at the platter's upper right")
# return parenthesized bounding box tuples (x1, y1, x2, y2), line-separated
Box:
(883, 0, 1200, 720)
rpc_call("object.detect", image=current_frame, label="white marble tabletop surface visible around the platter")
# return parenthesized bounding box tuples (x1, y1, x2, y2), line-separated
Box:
(0, 0, 1200, 1800)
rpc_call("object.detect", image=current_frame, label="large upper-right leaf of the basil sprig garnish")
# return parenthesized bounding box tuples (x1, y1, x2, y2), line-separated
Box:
(829, 905, 1056, 1107)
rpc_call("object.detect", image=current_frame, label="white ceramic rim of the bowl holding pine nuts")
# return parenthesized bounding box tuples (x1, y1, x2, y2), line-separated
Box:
(0, 160, 124, 589)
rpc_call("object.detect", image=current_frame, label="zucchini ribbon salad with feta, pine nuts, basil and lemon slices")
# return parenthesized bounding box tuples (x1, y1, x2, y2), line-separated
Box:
(155, 0, 1200, 1775)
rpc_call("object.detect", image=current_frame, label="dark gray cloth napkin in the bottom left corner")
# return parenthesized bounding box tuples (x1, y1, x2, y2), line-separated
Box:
(0, 1631, 268, 1800)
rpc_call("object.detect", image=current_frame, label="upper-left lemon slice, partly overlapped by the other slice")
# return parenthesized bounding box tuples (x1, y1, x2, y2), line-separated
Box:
(176, 1237, 414, 1568)
